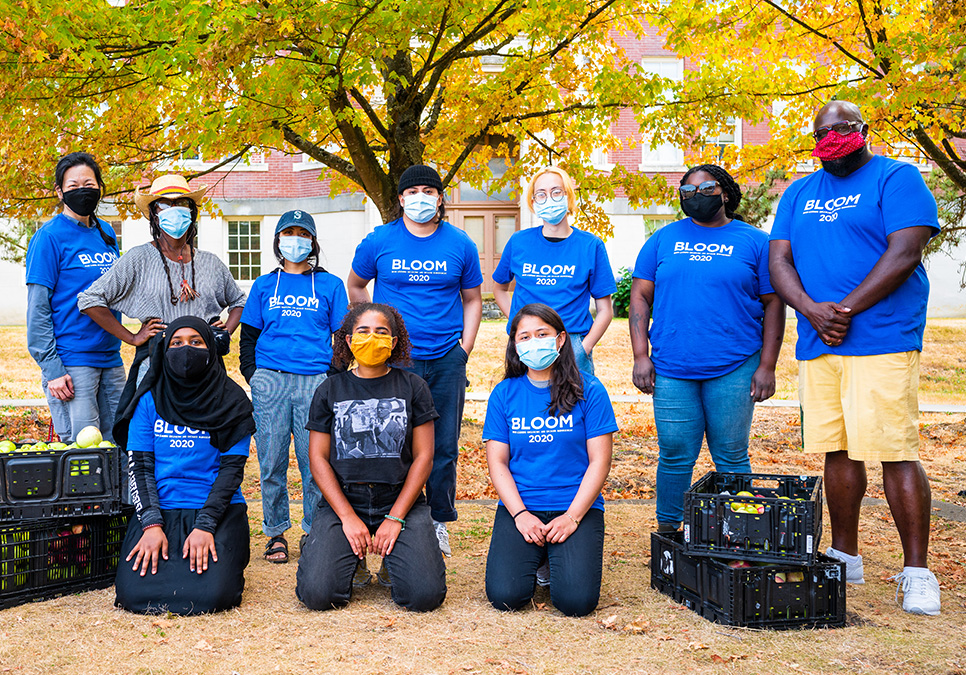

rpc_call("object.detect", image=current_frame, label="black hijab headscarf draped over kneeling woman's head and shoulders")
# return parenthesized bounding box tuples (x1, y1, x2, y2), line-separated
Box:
(114, 316, 255, 452)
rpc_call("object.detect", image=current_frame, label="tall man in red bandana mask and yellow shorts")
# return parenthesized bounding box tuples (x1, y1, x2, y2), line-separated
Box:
(769, 101, 940, 614)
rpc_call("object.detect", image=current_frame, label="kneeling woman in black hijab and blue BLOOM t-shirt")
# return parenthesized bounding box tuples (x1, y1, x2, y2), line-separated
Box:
(114, 316, 255, 615)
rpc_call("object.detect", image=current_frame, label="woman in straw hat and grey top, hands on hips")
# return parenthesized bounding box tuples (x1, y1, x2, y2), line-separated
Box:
(77, 174, 245, 394)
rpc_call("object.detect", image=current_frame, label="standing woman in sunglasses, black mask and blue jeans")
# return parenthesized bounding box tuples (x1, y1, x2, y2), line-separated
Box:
(630, 164, 785, 531)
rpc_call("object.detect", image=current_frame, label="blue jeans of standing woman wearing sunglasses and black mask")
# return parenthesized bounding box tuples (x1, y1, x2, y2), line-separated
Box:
(654, 352, 761, 524)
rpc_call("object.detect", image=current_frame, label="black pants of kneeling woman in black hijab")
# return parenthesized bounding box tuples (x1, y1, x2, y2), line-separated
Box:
(114, 504, 251, 616)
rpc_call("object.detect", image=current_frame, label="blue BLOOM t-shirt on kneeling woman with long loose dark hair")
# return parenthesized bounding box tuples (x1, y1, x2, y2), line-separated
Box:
(483, 373, 618, 511)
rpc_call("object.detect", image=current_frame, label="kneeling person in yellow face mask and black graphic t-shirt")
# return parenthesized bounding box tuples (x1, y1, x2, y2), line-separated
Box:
(295, 303, 446, 612)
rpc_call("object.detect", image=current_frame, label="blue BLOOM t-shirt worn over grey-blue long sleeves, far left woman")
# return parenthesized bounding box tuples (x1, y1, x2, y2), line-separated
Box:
(27, 213, 121, 368)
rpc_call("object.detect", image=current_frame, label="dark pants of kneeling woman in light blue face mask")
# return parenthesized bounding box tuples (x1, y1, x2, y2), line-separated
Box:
(486, 505, 604, 616)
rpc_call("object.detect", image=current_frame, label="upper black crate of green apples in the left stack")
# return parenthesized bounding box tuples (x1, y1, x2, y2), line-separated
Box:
(0, 446, 121, 523)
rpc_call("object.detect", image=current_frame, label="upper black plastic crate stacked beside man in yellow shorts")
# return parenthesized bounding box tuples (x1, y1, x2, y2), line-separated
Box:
(684, 471, 822, 565)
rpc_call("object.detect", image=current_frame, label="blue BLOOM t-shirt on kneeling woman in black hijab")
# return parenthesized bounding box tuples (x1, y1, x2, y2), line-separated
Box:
(128, 392, 252, 509)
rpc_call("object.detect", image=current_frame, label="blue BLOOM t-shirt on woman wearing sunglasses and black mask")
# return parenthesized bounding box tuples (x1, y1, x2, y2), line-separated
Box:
(634, 218, 775, 380)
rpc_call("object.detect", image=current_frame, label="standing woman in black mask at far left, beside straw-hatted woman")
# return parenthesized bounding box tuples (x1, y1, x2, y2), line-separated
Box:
(27, 152, 124, 443)
